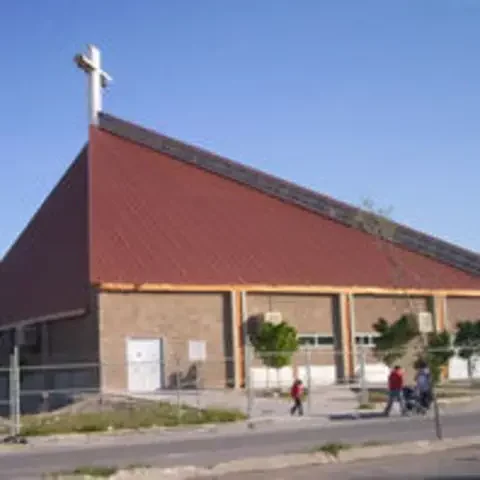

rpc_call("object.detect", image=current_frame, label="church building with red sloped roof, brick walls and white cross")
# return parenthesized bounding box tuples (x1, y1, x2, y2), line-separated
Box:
(0, 46, 480, 392)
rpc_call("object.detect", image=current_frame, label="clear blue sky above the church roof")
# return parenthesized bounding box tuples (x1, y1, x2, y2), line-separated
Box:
(0, 0, 480, 256)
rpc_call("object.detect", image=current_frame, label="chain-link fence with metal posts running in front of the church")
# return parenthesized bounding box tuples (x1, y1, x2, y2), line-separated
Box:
(0, 345, 480, 435)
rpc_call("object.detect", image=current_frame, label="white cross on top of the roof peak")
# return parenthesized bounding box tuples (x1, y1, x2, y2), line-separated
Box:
(74, 45, 112, 125)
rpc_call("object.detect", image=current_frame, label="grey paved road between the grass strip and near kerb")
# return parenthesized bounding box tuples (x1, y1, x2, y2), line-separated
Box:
(0, 412, 480, 480)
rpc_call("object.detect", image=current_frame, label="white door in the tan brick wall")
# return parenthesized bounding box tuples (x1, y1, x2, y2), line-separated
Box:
(127, 338, 163, 393)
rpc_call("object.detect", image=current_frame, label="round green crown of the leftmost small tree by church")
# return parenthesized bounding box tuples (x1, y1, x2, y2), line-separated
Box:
(251, 322, 298, 370)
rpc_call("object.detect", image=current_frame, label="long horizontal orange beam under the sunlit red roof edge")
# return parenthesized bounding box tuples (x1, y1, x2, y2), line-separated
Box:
(94, 282, 480, 297)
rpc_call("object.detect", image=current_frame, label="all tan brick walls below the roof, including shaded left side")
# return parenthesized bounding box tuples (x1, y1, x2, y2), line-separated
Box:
(13, 292, 480, 391)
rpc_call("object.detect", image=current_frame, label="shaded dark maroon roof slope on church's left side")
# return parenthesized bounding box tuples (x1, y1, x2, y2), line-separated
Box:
(0, 148, 89, 323)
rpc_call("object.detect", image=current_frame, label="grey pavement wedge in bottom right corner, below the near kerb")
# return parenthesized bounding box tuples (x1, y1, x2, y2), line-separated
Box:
(211, 448, 480, 480)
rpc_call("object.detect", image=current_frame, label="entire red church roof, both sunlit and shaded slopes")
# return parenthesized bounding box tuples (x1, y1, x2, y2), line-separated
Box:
(0, 115, 480, 323)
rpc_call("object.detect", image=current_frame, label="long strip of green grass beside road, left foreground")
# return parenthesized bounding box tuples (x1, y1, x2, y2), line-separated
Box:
(21, 402, 246, 436)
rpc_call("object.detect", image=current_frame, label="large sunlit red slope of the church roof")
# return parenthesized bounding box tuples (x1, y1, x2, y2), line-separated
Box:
(90, 129, 480, 289)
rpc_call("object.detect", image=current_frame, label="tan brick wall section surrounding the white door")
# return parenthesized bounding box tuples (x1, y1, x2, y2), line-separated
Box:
(98, 293, 234, 390)
